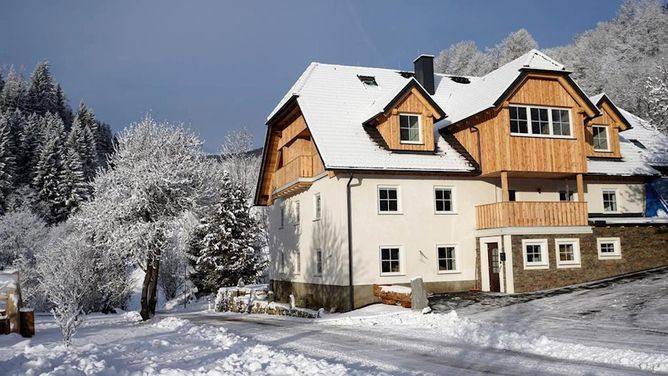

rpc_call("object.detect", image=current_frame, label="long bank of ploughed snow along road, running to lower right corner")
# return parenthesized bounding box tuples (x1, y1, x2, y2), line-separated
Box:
(319, 309, 668, 372)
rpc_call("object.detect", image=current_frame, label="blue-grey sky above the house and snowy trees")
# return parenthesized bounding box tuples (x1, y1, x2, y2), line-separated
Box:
(0, 0, 622, 152)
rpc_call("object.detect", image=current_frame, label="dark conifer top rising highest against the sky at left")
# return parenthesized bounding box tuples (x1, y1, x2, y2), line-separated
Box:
(26, 61, 59, 115)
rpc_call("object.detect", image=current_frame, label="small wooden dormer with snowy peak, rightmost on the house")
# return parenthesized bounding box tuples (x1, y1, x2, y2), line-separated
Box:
(586, 94, 631, 158)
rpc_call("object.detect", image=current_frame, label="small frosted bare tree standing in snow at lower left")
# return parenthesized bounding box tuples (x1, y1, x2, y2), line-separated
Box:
(36, 226, 96, 346)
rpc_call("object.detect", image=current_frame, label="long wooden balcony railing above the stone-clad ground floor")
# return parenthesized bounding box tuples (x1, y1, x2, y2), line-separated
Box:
(476, 201, 589, 230)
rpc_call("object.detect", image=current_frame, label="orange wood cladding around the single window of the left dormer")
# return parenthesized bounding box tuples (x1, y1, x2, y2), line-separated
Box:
(376, 88, 439, 151)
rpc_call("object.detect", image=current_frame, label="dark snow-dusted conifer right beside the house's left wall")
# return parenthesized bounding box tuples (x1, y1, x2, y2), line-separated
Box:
(189, 173, 266, 292)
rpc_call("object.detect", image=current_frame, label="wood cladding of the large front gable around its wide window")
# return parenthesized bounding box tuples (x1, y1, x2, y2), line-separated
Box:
(450, 74, 591, 176)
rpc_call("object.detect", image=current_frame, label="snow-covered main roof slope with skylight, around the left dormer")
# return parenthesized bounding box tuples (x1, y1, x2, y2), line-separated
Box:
(269, 63, 474, 172)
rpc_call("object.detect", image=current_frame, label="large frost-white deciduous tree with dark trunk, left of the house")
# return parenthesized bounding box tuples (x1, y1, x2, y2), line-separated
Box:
(82, 116, 220, 319)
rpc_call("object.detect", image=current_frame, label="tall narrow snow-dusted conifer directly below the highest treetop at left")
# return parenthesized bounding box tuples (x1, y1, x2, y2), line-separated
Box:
(32, 113, 67, 224)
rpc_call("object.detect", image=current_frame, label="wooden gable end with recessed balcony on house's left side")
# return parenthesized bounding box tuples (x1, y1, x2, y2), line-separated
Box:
(256, 105, 325, 205)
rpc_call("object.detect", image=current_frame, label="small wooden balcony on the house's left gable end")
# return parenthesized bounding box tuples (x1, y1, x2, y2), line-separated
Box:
(272, 154, 324, 198)
